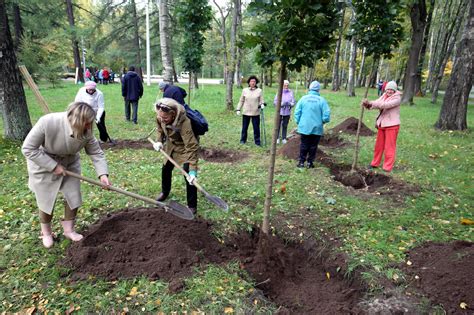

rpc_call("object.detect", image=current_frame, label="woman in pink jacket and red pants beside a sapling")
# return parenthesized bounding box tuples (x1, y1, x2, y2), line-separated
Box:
(362, 81, 402, 173)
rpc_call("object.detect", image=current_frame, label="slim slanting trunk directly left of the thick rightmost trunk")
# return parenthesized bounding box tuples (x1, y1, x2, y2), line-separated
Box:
(431, 1, 468, 104)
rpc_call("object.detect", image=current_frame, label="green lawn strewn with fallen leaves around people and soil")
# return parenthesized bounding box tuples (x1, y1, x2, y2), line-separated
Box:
(0, 83, 474, 313)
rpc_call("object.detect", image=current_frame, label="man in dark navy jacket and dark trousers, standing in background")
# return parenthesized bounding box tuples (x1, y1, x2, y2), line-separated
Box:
(122, 66, 143, 124)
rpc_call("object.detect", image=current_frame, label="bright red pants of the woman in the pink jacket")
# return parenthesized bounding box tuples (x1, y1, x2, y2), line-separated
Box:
(370, 125, 400, 172)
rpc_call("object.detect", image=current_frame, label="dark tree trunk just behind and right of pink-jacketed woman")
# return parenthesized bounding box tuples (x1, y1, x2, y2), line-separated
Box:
(402, 0, 427, 105)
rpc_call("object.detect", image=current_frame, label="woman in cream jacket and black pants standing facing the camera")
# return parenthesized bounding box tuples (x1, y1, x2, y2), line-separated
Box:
(237, 75, 265, 146)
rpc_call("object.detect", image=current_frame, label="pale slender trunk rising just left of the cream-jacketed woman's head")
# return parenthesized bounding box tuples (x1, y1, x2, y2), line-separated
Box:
(226, 0, 241, 110)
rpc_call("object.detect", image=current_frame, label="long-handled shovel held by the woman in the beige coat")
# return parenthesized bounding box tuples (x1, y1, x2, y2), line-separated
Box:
(64, 171, 194, 220)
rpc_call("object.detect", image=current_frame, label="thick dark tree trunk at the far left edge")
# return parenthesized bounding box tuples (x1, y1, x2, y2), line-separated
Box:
(0, 0, 31, 140)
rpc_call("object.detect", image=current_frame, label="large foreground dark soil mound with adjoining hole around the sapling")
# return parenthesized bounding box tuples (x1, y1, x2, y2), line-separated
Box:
(64, 208, 364, 314)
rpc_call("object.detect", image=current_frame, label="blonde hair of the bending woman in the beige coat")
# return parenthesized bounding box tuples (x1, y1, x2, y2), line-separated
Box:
(67, 102, 95, 139)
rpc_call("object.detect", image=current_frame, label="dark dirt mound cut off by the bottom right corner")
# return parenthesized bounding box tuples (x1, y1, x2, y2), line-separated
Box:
(401, 241, 474, 314)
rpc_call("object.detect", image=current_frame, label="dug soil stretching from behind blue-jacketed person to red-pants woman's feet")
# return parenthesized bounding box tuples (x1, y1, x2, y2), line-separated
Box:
(278, 136, 420, 200)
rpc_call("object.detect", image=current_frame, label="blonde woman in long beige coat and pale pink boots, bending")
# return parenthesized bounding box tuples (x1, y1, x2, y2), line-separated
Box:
(22, 102, 110, 248)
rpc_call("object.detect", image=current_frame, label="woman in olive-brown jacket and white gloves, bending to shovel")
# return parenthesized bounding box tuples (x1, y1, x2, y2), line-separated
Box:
(153, 98, 199, 214)
